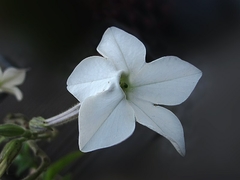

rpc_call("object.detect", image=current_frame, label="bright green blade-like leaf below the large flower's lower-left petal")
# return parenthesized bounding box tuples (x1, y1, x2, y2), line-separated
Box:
(43, 151, 83, 180)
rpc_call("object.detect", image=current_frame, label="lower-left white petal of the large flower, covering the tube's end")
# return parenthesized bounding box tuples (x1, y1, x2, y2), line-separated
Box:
(79, 84, 135, 152)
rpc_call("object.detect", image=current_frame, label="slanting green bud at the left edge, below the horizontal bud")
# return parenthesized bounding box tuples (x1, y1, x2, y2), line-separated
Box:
(0, 139, 22, 178)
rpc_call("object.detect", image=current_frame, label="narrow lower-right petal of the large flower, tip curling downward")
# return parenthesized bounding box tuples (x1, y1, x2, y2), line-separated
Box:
(131, 98, 185, 156)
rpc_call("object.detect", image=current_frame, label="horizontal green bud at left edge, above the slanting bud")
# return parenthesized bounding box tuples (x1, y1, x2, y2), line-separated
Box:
(0, 124, 25, 137)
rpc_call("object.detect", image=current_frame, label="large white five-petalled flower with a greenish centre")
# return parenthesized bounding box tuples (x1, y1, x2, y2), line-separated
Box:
(67, 27, 202, 155)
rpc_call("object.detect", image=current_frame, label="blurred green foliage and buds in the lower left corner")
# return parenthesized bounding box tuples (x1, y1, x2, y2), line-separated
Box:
(0, 114, 83, 180)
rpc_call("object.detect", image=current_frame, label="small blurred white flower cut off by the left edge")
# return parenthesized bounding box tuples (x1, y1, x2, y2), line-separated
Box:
(0, 67, 26, 101)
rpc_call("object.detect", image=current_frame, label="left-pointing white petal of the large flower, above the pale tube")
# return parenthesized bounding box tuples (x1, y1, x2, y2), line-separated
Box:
(67, 56, 120, 102)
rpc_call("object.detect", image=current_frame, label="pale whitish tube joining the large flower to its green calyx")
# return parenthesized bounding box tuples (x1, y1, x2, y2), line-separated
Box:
(45, 103, 81, 126)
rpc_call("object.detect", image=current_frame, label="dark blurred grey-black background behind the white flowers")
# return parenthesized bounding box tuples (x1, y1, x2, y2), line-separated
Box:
(0, 0, 240, 180)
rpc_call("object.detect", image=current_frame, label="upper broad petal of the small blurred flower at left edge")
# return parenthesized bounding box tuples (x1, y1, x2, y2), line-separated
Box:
(2, 67, 26, 87)
